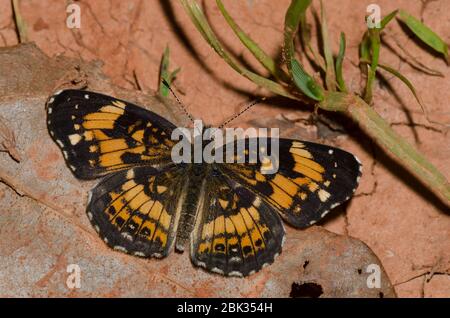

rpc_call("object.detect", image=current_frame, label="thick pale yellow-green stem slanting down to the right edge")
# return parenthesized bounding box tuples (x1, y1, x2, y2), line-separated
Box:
(319, 92, 450, 205)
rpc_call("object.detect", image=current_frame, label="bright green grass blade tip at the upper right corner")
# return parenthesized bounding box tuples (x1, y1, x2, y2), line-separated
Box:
(398, 10, 449, 62)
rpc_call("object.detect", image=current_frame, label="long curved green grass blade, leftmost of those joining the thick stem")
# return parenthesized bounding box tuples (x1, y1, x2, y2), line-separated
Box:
(180, 0, 299, 100)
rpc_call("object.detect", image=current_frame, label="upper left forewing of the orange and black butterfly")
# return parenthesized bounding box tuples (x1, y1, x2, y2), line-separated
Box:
(47, 90, 175, 179)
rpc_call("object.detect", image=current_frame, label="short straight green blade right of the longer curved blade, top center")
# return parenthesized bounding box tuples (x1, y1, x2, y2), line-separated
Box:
(216, 0, 290, 82)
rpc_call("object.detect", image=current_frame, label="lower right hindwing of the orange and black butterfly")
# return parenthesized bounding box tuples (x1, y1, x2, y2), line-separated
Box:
(191, 170, 284, 276)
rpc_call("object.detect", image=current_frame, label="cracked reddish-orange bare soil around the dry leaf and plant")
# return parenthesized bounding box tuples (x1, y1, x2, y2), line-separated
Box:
(0, 0, 450, 297)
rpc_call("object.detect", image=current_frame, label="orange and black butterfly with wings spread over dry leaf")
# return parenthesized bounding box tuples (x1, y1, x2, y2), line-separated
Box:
(47, 90, 361, 277)
